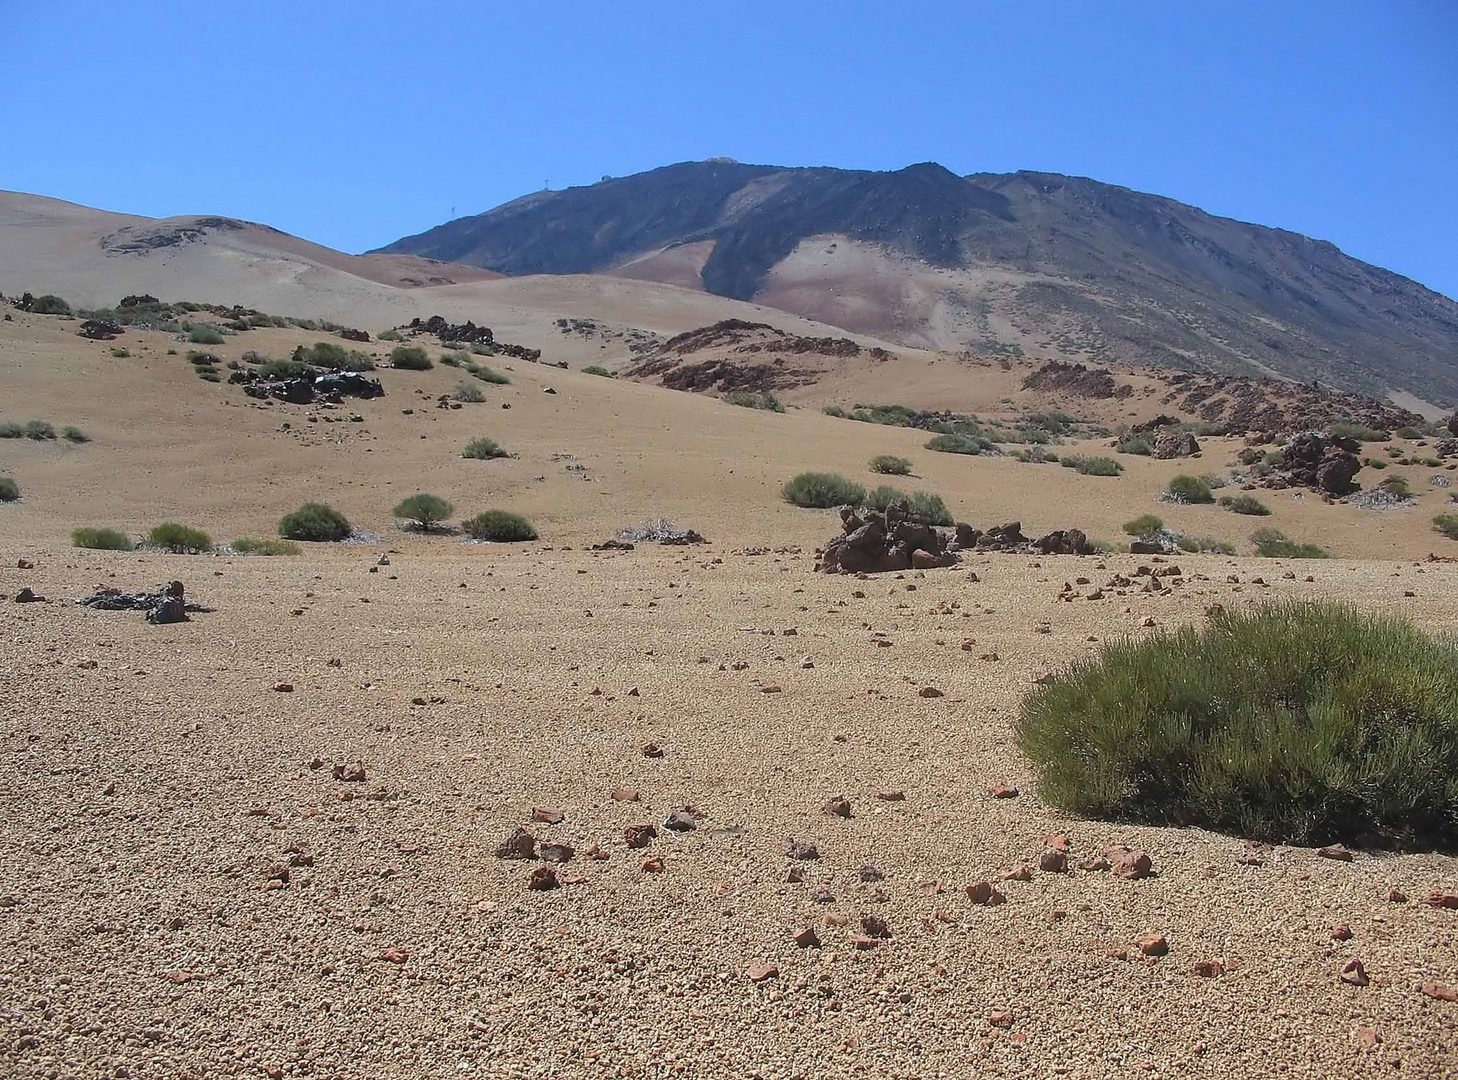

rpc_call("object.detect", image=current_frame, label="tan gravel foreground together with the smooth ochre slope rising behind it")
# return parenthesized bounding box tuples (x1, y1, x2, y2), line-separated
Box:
(0, 303, 1458, 1079)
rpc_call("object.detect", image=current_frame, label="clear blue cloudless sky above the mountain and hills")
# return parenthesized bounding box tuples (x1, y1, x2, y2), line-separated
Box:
(11, 0, 1458, 296)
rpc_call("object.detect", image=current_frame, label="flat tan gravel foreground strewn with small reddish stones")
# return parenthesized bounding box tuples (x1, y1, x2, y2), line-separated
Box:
(0, 544, 1458, 1079)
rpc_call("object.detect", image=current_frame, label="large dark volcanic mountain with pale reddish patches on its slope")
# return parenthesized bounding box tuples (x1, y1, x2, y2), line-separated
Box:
(375, 159, 1458, 404)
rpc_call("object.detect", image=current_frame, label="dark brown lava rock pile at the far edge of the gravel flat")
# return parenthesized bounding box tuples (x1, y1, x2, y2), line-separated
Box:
(815, 501, 1094, 574)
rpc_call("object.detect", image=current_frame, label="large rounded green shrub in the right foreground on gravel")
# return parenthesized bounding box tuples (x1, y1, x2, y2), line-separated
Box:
(1018, 605, 1458, 850)
